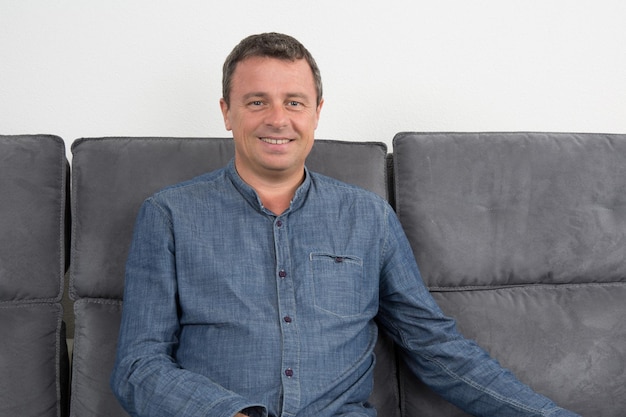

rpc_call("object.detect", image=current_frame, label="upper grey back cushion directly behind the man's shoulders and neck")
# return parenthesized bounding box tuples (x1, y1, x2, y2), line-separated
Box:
(70, 138, 387, 299)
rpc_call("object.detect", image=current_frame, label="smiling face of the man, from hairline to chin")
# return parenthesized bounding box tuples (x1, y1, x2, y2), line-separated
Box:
(220, 57, 322, 180)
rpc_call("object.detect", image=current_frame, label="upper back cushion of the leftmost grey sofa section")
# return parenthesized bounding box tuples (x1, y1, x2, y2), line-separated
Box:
(0, 135, 69, 302)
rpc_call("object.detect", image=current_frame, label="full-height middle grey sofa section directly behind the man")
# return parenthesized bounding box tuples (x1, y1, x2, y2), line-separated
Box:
(70, 138, 399, 417)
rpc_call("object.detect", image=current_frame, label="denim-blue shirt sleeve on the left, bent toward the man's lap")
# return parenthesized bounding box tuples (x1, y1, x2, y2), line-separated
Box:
(111, 199, 267, 417)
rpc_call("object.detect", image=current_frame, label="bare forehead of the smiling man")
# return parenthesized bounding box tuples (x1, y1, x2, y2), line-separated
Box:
(232, 57, 315, 95)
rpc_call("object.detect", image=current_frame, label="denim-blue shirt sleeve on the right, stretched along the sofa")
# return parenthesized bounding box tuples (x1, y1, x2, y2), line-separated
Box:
(378, 213, 577, 417)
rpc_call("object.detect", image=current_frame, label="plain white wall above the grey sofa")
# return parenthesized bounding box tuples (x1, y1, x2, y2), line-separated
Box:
(0, 0, 626, 158)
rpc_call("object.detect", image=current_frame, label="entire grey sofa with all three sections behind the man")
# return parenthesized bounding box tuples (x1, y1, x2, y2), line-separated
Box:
(0, 133, 626, 417)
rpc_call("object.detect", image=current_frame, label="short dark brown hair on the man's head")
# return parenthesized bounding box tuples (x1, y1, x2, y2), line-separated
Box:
(222, 32, 322, 106)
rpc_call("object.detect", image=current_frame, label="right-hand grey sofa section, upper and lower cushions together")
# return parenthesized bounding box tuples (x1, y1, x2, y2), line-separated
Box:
(393, 133, 626, 417)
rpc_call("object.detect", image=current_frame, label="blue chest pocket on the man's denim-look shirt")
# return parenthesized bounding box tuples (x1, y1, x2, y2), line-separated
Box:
(309, 253, 363, 317)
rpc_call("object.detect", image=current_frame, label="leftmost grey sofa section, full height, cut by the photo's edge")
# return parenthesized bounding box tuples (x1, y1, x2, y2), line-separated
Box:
(0, 135, 69, 417)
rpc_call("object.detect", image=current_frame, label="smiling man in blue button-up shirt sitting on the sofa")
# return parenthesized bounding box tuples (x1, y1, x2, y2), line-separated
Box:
(111, 33, 575, 417)
